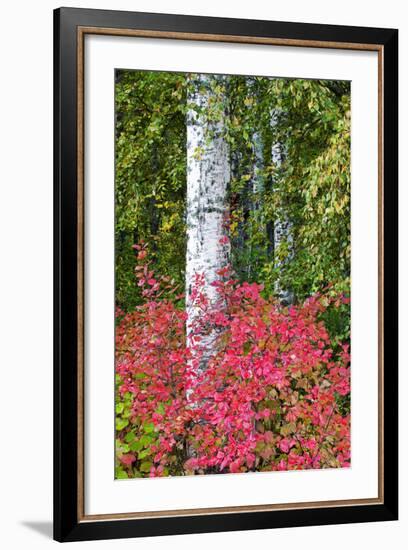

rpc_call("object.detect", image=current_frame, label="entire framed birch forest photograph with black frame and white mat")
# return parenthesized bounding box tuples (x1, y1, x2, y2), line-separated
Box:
(54, 8, 398, 541)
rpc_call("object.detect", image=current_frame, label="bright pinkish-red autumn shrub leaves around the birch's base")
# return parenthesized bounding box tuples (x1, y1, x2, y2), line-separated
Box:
(116, 245, 350, 478)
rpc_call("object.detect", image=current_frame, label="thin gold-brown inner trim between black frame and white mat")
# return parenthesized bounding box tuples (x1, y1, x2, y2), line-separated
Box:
(77, 26, 384, 522)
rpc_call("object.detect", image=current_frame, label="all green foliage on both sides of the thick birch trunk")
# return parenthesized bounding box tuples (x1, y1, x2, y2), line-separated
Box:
(115, 70, 350, 310)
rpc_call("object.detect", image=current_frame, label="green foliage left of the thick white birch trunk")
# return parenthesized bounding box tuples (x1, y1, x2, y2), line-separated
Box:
(115, 70, 186, 311)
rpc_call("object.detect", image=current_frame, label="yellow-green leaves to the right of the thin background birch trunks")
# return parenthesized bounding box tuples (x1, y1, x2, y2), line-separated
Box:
(275, 81, 350, 299)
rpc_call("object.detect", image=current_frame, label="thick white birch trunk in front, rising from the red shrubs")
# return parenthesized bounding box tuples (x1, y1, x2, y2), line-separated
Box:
(186, 75, 230, 376)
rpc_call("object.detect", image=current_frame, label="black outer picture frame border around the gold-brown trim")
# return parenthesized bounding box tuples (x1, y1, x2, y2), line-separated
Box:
(54, 8, 398, 542)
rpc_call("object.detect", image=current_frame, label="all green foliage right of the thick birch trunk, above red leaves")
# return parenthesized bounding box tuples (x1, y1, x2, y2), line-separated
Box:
(223, 77, 350, 300)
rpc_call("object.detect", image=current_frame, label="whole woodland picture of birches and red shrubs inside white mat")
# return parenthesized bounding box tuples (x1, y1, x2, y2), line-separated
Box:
(115, 70, 350, 477)
